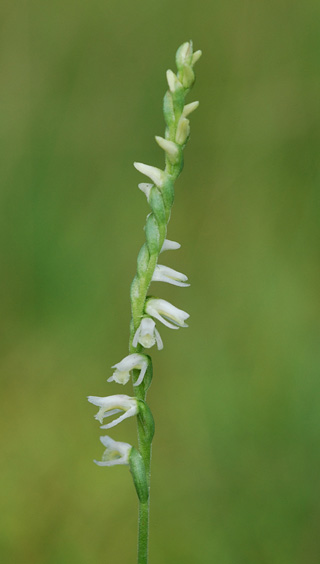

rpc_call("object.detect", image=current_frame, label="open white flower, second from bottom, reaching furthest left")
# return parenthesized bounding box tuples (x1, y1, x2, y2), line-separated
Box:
(88, 395, 138, 429)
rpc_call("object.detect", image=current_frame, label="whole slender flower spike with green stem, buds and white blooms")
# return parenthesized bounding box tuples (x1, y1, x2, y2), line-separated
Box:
(88, 41, 201, 564)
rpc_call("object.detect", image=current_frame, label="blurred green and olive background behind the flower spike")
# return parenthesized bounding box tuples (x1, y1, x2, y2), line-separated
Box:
(0, 0, 320, 564)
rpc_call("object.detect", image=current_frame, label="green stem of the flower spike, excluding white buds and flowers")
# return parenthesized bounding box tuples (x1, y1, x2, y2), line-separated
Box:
(129, 43, 199, 564)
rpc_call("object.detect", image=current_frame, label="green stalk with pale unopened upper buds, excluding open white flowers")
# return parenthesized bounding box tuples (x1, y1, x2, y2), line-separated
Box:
(129, 42, 201, 564)
